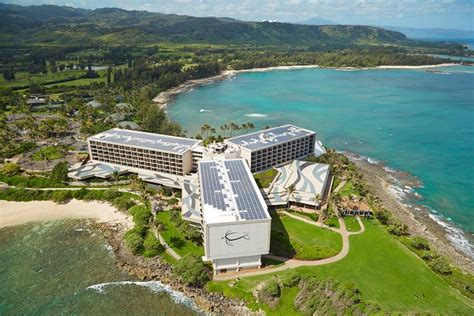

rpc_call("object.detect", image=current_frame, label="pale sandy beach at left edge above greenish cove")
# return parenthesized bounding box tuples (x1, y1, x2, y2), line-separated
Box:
(0, 200, 132, 228)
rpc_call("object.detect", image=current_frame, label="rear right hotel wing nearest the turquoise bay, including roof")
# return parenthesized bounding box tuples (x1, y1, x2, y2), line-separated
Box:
(225, 125, 316, 173)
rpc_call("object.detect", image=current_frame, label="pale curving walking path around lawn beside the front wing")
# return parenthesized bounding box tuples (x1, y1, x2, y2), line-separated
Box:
(214, 211, 365, 281)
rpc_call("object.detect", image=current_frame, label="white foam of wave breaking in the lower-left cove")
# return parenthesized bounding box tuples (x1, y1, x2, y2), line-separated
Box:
(87, 281, 200, 311)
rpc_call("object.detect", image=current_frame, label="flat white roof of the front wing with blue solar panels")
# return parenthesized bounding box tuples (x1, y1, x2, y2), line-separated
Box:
(199, 159, 270, 224)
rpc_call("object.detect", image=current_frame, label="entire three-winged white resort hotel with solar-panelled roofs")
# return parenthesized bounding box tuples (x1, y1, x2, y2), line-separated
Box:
(68, 125, 332, 273)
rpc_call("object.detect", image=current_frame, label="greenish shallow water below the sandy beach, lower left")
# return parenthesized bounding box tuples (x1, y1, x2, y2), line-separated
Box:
(0, 220, 197, 315)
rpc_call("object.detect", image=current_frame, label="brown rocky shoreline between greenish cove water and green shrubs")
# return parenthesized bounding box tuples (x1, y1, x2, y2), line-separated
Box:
(92, 222, 254, 315)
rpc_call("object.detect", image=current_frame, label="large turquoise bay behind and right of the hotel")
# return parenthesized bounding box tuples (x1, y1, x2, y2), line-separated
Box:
(168, 66, 474, 256)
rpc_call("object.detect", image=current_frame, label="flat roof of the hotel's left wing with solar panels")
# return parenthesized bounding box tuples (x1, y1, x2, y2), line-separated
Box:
(89, 128, 201, 154)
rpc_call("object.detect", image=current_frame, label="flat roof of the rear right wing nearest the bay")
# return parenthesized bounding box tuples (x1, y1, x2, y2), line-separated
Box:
(226, 125, 316, 151)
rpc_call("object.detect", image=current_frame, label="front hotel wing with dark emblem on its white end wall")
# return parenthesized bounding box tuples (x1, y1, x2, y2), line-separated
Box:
(199, 159, 271, 273)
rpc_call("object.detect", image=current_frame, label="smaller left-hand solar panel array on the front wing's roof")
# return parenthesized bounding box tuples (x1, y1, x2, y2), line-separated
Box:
(199, 161, 226, 211)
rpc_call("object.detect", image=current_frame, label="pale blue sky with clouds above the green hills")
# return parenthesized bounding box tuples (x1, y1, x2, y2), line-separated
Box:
(4, 0, 474, 30)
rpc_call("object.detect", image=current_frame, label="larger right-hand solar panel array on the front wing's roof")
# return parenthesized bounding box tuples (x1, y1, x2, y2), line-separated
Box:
(224, 160, 268, 220)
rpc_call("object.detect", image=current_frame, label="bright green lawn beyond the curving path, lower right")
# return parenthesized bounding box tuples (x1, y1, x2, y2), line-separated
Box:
(210, 221, 474, 315)
